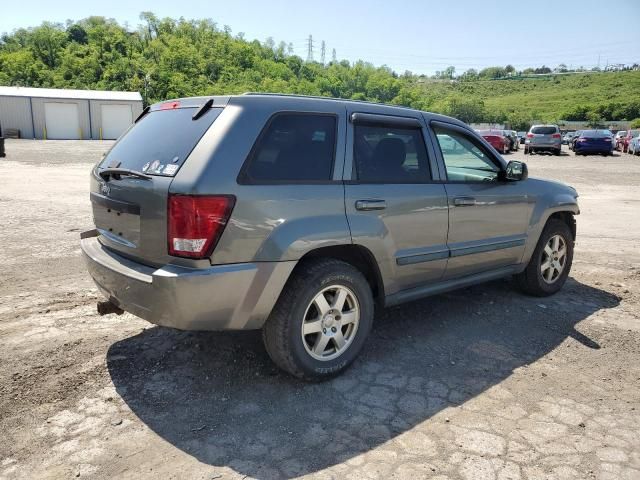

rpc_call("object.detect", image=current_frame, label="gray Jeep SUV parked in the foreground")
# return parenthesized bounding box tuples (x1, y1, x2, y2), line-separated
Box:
(81, 94, 579, 380)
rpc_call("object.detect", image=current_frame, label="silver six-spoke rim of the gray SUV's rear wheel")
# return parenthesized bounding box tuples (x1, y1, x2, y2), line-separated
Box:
(300, 285, 360, 362)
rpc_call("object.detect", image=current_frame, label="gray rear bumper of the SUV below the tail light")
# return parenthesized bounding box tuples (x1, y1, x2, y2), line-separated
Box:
(80, 232, 296, 330)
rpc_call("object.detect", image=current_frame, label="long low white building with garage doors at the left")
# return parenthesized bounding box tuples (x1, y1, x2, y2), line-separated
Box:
(0, 86, 142, 140)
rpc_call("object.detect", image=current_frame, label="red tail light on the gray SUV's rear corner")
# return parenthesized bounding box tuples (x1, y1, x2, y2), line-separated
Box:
(167, 195, 235, 258)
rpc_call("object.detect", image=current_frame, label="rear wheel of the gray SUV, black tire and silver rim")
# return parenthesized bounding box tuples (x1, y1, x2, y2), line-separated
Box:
(263, 258, 374, 381)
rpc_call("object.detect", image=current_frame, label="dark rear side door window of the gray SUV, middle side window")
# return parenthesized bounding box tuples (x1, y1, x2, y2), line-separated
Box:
(353, 125, 431, 183)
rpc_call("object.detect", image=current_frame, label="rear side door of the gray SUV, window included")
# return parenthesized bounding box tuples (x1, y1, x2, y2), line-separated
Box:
(345, 108, 448, 295)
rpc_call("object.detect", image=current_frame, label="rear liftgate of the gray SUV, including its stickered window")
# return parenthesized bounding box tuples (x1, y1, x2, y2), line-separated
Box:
(90, 102, 222, 265)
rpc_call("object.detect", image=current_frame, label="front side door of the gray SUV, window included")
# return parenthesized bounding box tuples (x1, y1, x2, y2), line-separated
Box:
(431, 122, 535, 279)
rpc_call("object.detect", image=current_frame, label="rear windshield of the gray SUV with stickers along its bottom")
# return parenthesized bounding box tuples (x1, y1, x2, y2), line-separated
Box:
(100, 108, 222, 176)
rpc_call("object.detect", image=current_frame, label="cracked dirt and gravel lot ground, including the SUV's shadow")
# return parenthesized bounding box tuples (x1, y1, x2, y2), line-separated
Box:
(0, 140, 640, 480)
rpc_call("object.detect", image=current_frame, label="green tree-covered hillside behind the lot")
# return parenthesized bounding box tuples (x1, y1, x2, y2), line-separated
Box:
(0, 12, 640, 129)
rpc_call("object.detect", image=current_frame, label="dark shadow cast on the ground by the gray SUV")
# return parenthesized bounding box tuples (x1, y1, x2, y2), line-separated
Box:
(107, 279, 620, 478)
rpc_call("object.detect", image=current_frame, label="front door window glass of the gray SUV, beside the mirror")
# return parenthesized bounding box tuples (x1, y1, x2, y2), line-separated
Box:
(434, 127, 500, 182)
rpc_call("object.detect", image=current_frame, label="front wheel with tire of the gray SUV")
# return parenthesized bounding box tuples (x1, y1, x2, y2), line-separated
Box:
(516, 219, 574, 297)
